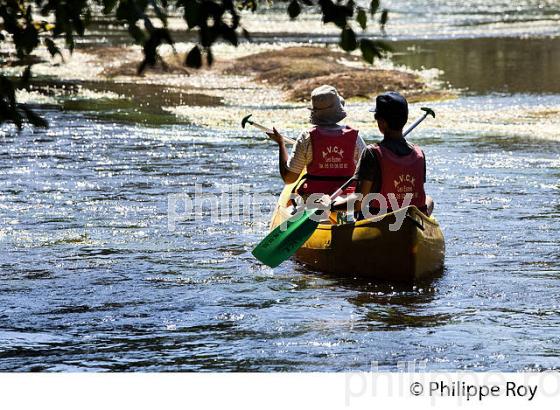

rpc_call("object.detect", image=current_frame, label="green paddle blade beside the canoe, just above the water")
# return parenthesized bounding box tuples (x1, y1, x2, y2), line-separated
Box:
(253, 209, 319, 268)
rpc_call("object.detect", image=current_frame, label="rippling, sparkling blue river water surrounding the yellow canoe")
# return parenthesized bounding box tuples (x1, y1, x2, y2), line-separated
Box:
(0, 1, 560, 371)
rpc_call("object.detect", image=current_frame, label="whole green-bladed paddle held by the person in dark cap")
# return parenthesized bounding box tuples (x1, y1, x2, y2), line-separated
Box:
(253, 107, 435, 268)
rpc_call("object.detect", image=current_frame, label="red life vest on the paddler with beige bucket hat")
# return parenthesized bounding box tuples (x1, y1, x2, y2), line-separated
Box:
(298, 126, 358, 195)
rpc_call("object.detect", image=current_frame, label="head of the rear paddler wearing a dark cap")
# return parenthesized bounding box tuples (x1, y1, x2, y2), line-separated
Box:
(370, 91, 408, 134)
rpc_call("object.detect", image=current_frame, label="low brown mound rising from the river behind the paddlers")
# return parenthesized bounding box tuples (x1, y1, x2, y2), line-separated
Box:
(76, 46, 451, 116)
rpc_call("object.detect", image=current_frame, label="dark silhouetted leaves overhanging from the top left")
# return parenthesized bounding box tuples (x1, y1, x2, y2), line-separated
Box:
(0, 0, 388, 128)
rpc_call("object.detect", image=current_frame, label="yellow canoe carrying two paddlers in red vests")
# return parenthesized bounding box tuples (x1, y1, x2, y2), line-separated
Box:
(270, 178, 445, 283)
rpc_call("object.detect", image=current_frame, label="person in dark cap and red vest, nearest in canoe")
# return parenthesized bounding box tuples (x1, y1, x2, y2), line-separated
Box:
(331, 91, 434, 219)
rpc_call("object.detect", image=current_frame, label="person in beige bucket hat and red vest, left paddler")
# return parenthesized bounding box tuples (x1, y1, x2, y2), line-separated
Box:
(268, 85, 366, 197)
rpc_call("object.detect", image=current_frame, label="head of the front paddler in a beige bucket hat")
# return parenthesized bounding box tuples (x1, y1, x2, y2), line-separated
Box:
(309, 85, 347, 125)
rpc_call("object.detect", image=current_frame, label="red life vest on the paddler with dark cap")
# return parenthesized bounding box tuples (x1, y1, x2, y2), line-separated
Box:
(370, 145, 426, 212)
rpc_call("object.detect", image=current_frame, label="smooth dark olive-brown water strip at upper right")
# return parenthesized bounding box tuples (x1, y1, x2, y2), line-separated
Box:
(392, 37, 560, 94)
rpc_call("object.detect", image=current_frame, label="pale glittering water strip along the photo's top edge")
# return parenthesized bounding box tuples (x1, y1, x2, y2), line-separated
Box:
(218, 0, 560, 42)
